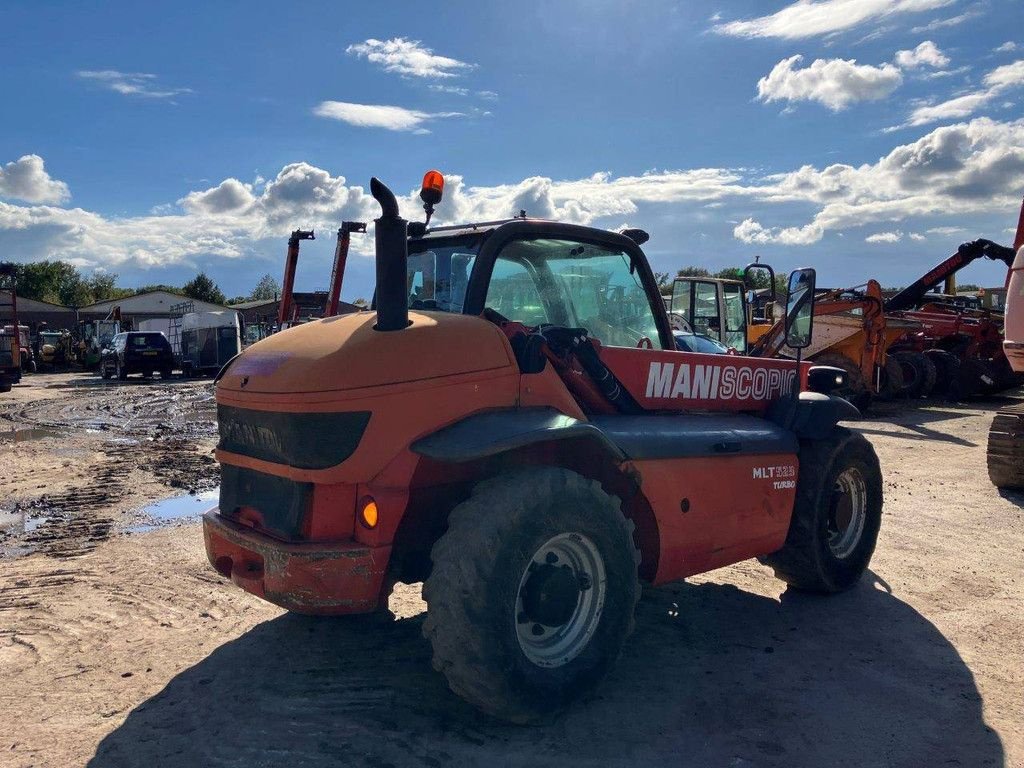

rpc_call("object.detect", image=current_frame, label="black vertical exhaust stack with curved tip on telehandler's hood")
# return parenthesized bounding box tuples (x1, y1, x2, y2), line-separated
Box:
(370, 176, 409, 331)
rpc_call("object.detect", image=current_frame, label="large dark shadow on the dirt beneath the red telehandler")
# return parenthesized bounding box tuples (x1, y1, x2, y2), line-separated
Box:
(89, 580, 1004, 768)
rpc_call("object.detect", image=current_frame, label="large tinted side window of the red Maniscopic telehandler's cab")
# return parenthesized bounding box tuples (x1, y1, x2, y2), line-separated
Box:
(484, 239, 660, 347)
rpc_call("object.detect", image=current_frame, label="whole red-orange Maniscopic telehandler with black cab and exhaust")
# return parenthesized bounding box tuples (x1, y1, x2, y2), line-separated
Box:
(204, 172, 882, 722)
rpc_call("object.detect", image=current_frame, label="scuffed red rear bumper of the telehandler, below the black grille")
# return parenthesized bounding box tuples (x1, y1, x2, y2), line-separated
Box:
(203, 510, 391, 614)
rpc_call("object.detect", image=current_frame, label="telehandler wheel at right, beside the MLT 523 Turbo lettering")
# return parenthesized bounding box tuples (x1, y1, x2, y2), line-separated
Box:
(761, 427, 882, 593)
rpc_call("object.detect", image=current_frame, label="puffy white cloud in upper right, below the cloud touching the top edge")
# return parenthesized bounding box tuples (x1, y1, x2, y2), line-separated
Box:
(758, 55, 903, 112)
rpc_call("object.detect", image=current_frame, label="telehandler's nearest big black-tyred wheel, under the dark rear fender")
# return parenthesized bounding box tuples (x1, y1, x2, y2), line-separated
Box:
(423, 468, 640, 723)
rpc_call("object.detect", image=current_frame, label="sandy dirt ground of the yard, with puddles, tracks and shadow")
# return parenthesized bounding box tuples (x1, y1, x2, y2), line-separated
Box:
(0, 375, 1024, 768)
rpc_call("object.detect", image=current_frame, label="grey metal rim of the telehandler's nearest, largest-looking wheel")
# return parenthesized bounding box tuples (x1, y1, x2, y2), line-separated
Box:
(514, 532, 607, 668)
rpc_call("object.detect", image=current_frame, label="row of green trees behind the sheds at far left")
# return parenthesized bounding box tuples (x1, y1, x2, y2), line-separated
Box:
(7, 261, 281, 307)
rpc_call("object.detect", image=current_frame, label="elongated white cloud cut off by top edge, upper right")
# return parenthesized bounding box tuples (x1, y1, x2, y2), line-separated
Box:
(713, 0, 955, 40)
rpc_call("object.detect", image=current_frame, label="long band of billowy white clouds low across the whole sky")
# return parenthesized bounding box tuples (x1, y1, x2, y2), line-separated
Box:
(0, 118, 1024, 268)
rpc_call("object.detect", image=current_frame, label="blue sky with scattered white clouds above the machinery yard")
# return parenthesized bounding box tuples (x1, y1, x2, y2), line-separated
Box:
(0, 0, 1024, 298)
